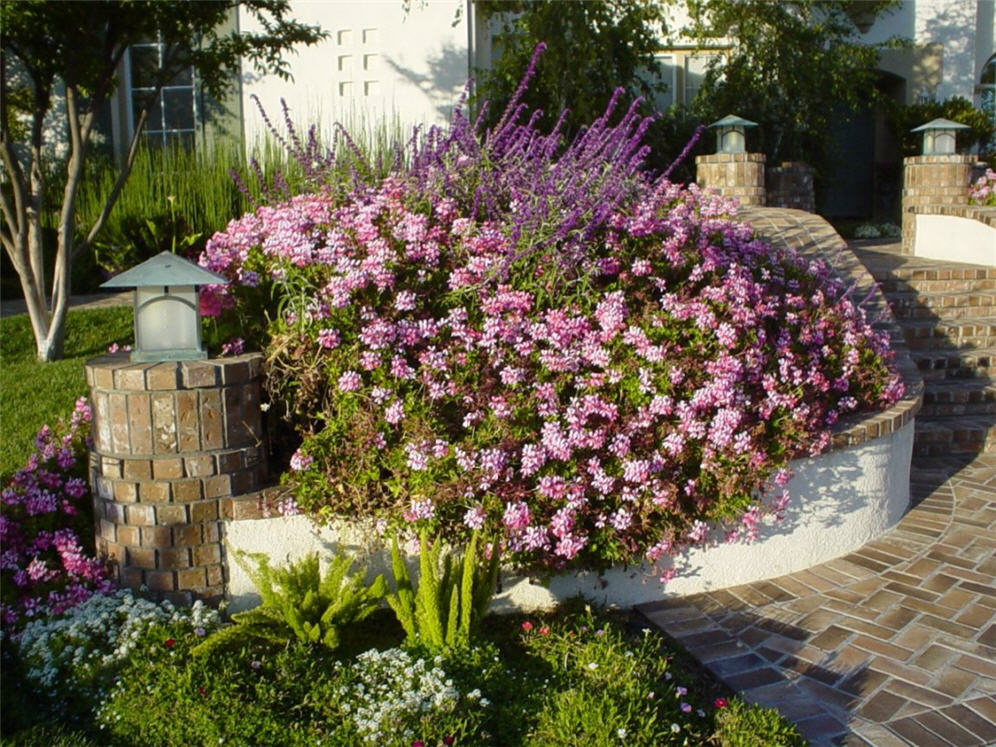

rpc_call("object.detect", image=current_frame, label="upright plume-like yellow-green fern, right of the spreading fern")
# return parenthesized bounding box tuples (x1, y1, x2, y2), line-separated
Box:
(387, 530, 499, 651)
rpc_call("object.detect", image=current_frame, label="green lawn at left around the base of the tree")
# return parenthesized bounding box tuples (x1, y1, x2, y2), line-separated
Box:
(0, 307, 134, 475)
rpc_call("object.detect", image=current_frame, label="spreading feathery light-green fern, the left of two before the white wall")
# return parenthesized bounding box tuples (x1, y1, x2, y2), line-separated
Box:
(193, 552, 385, 656)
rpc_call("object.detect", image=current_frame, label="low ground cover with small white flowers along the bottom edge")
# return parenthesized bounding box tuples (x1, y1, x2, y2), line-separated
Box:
(4, 592, 803, 747)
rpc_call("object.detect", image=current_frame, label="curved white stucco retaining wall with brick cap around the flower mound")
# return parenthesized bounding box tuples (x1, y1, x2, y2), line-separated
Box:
(226, 207, 923, 609)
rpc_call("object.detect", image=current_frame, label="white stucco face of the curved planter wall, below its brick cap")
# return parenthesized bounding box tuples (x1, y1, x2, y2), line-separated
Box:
(226, 421, 913, 611)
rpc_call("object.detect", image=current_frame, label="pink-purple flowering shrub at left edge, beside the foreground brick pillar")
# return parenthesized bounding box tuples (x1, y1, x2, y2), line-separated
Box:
(0, 398, 111, 629)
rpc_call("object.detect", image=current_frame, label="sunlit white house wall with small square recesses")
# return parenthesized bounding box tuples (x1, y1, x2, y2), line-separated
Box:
(239, 0, 470, 146)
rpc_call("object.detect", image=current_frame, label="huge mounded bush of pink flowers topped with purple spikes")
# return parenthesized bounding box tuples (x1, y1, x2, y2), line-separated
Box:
(201, 46, 903, 578)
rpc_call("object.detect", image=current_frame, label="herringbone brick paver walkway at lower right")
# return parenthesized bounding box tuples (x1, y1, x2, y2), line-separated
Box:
(640, 455, 996, 747)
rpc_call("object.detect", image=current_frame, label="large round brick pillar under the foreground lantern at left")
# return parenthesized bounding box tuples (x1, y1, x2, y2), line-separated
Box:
(86, 353, 266, 604)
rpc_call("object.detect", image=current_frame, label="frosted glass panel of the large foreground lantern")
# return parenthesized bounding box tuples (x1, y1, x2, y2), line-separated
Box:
(135, 285, 201, 352)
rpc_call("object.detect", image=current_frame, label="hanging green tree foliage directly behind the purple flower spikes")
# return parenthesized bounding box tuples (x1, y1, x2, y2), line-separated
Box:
(477, 0, 668, 136)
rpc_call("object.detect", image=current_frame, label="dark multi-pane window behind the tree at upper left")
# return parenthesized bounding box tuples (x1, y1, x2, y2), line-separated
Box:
(126, 39, 197, 146)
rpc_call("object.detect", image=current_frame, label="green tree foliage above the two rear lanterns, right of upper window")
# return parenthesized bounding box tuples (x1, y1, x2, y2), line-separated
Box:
(684, 0, 900, 169)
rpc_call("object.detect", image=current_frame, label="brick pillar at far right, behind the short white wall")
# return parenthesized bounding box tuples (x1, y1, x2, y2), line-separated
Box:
(903, 155, 975, 254)
